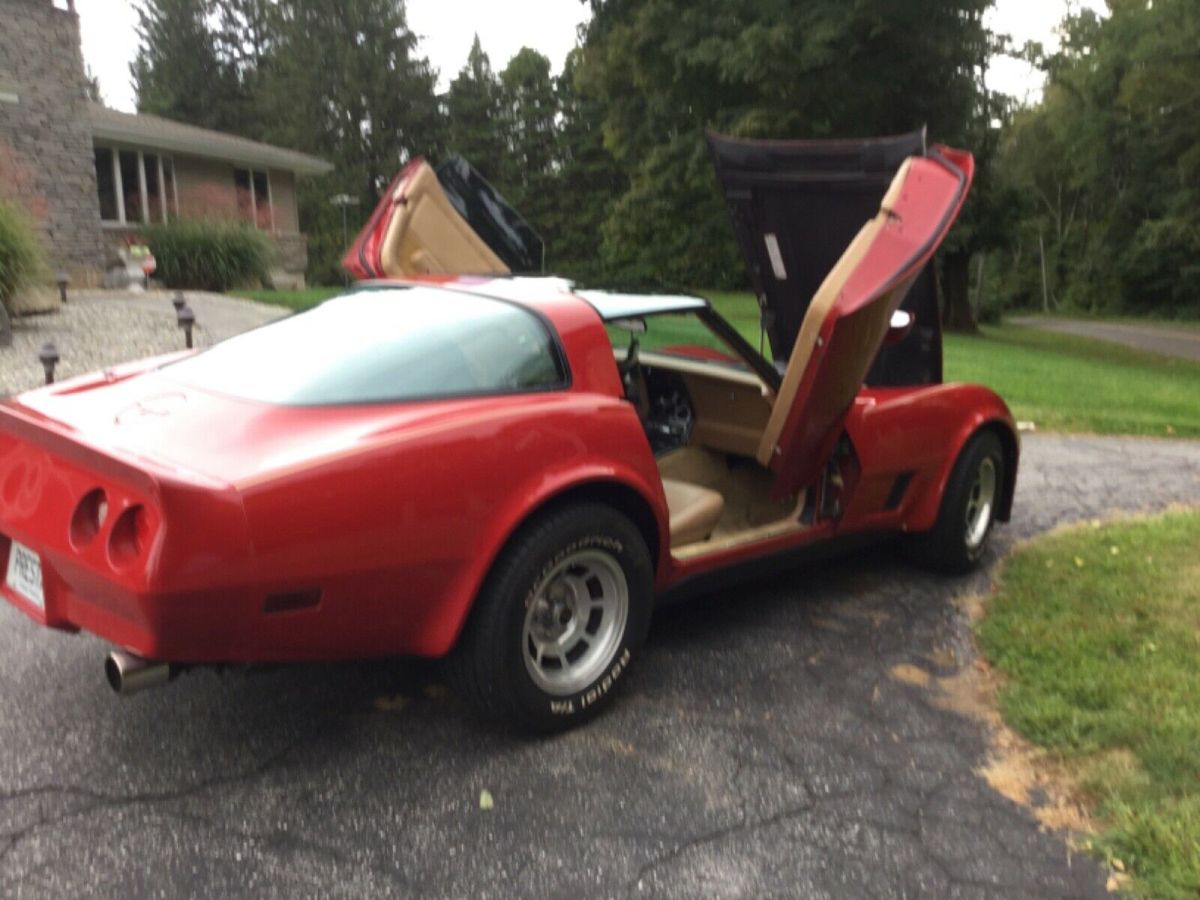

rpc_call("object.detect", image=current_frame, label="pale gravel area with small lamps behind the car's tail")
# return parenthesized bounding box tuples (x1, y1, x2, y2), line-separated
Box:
(0, 290, 288, 395)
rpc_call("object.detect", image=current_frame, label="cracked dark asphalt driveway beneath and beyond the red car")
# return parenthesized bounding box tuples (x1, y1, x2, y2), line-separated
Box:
(0, 434, 1200, 898)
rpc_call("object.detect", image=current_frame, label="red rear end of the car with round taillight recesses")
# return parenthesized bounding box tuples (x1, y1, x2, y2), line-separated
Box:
(0, 403, 261, 659)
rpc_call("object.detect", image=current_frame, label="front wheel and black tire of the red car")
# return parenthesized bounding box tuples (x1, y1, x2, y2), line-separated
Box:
(905, 431, 1008, 575)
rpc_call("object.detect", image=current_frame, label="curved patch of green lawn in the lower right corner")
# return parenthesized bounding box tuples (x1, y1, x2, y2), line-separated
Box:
(978, 510, 1200, 898)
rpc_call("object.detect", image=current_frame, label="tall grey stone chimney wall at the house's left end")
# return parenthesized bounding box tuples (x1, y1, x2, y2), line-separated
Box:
(0, 0, 104, 281)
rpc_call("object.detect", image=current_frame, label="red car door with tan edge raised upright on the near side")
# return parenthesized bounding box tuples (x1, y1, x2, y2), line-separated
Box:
(734, 146, 974, 494)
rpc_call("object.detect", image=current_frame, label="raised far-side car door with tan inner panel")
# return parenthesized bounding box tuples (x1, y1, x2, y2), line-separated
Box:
(342, 156, 544, 278)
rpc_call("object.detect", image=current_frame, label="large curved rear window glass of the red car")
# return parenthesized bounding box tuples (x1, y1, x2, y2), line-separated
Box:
(162, 288, 566, 406)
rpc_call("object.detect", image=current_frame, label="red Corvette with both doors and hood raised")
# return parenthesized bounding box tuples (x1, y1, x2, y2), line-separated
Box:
(0, 130, 1018, 731)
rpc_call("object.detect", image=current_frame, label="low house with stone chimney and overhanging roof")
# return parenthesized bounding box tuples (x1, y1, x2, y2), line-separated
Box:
(0, 0, 332, 292)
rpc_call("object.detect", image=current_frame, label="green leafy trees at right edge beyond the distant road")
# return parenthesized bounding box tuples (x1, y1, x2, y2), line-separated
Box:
(1002, 0, 1200, 316)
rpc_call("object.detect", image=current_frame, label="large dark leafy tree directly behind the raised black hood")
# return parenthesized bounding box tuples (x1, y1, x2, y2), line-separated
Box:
(581, 0, 990, 303)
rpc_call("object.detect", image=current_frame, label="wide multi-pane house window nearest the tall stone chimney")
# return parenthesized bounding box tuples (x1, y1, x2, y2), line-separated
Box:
(95, 146, 179, 224)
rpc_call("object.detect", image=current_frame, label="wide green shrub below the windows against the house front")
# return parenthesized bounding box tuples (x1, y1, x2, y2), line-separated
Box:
(144, 220, 271, 292)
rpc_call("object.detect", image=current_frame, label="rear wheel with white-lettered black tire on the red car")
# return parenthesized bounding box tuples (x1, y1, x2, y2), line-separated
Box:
(448, 503, 654, 733)
